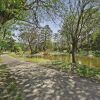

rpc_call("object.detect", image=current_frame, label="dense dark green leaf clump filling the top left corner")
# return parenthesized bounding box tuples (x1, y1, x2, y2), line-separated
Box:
(0, 0, 25, 24)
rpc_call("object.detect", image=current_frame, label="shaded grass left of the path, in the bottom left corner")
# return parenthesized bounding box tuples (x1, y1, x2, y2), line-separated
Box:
(0, 65, 23, 100)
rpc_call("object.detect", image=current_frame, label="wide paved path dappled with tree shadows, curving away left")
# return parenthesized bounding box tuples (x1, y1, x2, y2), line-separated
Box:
(0, 55, 100, 100)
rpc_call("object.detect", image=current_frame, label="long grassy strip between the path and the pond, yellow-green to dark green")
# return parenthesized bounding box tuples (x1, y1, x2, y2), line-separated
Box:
(8, 54, 100, 81)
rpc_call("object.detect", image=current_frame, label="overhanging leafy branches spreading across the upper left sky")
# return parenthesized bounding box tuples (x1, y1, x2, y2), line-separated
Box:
(0, 0, 62, 25)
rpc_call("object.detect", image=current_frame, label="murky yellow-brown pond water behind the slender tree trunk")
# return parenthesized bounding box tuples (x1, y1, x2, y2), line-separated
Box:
(34, 55, 100, 68)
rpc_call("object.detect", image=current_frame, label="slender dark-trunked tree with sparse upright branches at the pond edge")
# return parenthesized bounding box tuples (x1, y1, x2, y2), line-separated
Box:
(61, 0, 100, 63)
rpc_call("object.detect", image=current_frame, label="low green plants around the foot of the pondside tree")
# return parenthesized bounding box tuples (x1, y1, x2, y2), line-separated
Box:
(51, 61, 100, 82)
